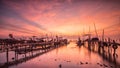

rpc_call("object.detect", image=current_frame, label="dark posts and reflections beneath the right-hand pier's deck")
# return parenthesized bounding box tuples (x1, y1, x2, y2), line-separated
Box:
(84, 41, 120, 68)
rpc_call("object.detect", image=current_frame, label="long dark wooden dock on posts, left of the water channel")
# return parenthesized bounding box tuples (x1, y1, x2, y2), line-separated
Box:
(0, 39, 67, 68)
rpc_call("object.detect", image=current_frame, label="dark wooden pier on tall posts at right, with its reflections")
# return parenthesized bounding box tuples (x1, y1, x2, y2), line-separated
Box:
(77, 34, 120, 68)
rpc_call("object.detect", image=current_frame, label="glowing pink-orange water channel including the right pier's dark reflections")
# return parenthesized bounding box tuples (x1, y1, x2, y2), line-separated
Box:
(0, 42, 119, 68)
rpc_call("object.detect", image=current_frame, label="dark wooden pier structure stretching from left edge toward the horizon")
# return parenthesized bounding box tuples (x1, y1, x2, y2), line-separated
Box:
(0, 38, 68, 68)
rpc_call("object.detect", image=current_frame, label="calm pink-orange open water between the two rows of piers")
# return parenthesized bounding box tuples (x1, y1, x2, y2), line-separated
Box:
(0, 42, 120, 68)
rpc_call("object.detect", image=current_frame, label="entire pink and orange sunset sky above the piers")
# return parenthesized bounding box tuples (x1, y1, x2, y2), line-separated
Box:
(0, 0, 120, 38)
